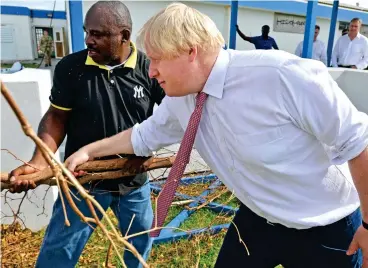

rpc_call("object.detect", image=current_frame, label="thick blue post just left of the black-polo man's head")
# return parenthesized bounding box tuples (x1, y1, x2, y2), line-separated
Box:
(68, 0, 85, 53)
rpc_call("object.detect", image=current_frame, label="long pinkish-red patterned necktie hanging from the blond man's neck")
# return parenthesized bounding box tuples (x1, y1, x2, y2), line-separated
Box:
(150, 92, 208, 237)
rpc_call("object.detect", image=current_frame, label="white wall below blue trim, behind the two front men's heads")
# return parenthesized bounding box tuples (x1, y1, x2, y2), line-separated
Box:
(83, 1, 341, 53)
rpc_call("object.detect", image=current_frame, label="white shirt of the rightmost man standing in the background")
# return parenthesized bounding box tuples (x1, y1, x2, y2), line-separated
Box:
(331, 33, 368, 70)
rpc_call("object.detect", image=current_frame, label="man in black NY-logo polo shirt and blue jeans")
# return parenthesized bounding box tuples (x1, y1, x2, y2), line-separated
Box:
(12, 1, 164, 268)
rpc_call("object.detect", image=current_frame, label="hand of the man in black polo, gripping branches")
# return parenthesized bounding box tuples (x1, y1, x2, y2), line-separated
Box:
(9, 160, 46, 193)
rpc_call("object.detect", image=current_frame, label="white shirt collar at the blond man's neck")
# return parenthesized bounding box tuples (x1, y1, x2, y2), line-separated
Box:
(202, 49, 230, 99)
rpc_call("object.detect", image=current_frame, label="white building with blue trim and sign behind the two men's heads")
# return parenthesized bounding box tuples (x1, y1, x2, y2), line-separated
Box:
(78, 1, 368, 53)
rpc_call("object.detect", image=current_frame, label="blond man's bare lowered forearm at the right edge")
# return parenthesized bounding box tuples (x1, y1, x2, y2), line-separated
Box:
(349, 147, 368, 223)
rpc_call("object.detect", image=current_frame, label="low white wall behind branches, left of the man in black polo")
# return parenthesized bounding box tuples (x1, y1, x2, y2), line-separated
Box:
(0, 68, 58, 231)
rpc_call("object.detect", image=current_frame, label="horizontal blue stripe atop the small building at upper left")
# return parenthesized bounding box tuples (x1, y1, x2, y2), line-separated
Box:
(1, 6, 66, 20)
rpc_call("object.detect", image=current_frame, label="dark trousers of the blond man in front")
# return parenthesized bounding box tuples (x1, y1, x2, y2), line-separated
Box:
(215, 205, 363, 268)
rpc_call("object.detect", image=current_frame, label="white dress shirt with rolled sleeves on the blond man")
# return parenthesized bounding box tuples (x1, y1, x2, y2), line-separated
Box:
(131, 50, 368, 229)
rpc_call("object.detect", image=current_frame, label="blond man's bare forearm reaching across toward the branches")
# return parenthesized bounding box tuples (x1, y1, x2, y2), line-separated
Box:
(82, 128, 134, 158)
